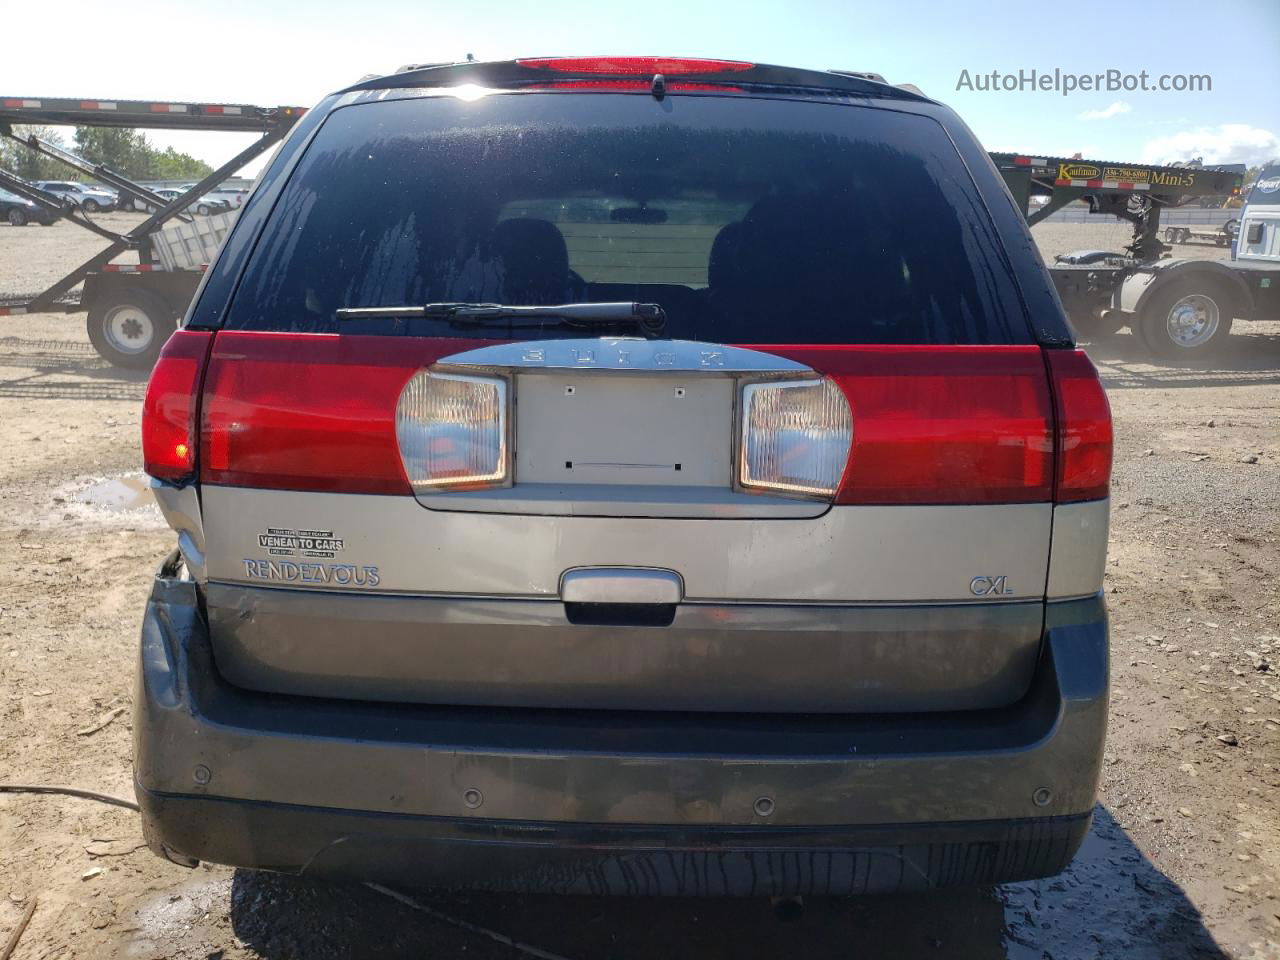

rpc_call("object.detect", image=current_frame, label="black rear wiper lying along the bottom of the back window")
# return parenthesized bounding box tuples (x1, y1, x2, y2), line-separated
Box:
(335, 303, 667, 339)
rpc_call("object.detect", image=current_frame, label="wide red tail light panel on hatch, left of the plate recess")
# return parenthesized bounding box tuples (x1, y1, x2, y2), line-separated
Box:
(200, 333, 485, 494)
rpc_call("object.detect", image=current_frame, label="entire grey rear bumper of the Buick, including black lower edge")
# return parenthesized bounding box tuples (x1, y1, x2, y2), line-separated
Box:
(134, 555, 1107, 893)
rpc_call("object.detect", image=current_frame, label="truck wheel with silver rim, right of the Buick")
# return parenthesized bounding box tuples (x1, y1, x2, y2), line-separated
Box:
(1138, 276, 1235, 360)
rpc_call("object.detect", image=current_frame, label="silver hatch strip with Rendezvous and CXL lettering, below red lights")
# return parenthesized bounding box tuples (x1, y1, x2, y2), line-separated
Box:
(201, 485, 1054, 603)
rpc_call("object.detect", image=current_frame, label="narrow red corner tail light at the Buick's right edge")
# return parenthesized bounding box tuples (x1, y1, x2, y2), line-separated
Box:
(1044, 349, 1112, 503)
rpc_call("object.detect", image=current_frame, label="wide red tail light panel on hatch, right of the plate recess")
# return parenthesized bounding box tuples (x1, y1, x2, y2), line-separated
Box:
(755, 346, 1053, 504)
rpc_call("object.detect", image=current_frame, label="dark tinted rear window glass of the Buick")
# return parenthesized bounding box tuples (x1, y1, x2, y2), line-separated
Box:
(227, 93, 1030, 343)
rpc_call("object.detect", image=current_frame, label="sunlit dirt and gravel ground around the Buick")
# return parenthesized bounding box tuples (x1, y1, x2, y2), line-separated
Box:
(0, 215, 1280, 960)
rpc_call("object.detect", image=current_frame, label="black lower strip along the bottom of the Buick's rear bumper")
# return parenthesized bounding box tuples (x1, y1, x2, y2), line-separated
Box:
(137, 787, 1091, 896)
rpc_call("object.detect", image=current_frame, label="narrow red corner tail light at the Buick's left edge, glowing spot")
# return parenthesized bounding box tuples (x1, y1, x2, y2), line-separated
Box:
(142, 330, 214, 480)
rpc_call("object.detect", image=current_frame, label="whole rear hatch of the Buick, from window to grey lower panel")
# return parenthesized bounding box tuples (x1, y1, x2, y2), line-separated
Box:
(147, 79, 1110, 712)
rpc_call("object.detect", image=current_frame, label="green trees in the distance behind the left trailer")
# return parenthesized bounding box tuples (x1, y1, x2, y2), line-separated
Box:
(0, 127, 214, 180)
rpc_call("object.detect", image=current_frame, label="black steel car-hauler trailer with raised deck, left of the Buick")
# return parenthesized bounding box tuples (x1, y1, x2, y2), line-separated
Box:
(0, 97, 306, 369)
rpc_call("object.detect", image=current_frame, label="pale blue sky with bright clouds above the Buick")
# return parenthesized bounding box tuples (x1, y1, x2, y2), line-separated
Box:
(0, 0, 1280, 173)
